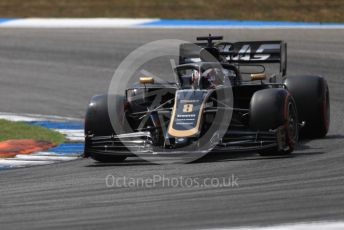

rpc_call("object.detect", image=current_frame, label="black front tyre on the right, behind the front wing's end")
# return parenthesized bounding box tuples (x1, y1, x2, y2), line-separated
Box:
(250, 88, 299, 156)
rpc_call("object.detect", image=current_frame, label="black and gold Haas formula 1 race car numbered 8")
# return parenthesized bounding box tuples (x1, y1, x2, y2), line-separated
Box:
(84, 35, 330, 162)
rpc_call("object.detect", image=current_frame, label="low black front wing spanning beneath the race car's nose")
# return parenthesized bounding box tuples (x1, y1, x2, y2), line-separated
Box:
(84, 126, 286, 157)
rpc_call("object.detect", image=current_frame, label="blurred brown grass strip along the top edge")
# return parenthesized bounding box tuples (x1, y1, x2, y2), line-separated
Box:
(0, 0, 344, 22)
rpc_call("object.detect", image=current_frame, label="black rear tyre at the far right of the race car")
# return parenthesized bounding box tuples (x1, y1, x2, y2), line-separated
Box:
(284, 76, 330, 138)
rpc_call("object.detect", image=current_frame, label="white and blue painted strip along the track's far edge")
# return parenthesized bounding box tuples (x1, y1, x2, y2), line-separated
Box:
(0, 18, 344, 30)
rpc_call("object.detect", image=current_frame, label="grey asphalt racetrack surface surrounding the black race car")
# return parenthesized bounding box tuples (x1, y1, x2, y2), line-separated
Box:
(0, 29, 344, 229)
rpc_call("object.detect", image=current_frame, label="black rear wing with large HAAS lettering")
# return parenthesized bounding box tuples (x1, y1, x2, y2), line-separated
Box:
(179, 41, 287, 76)
